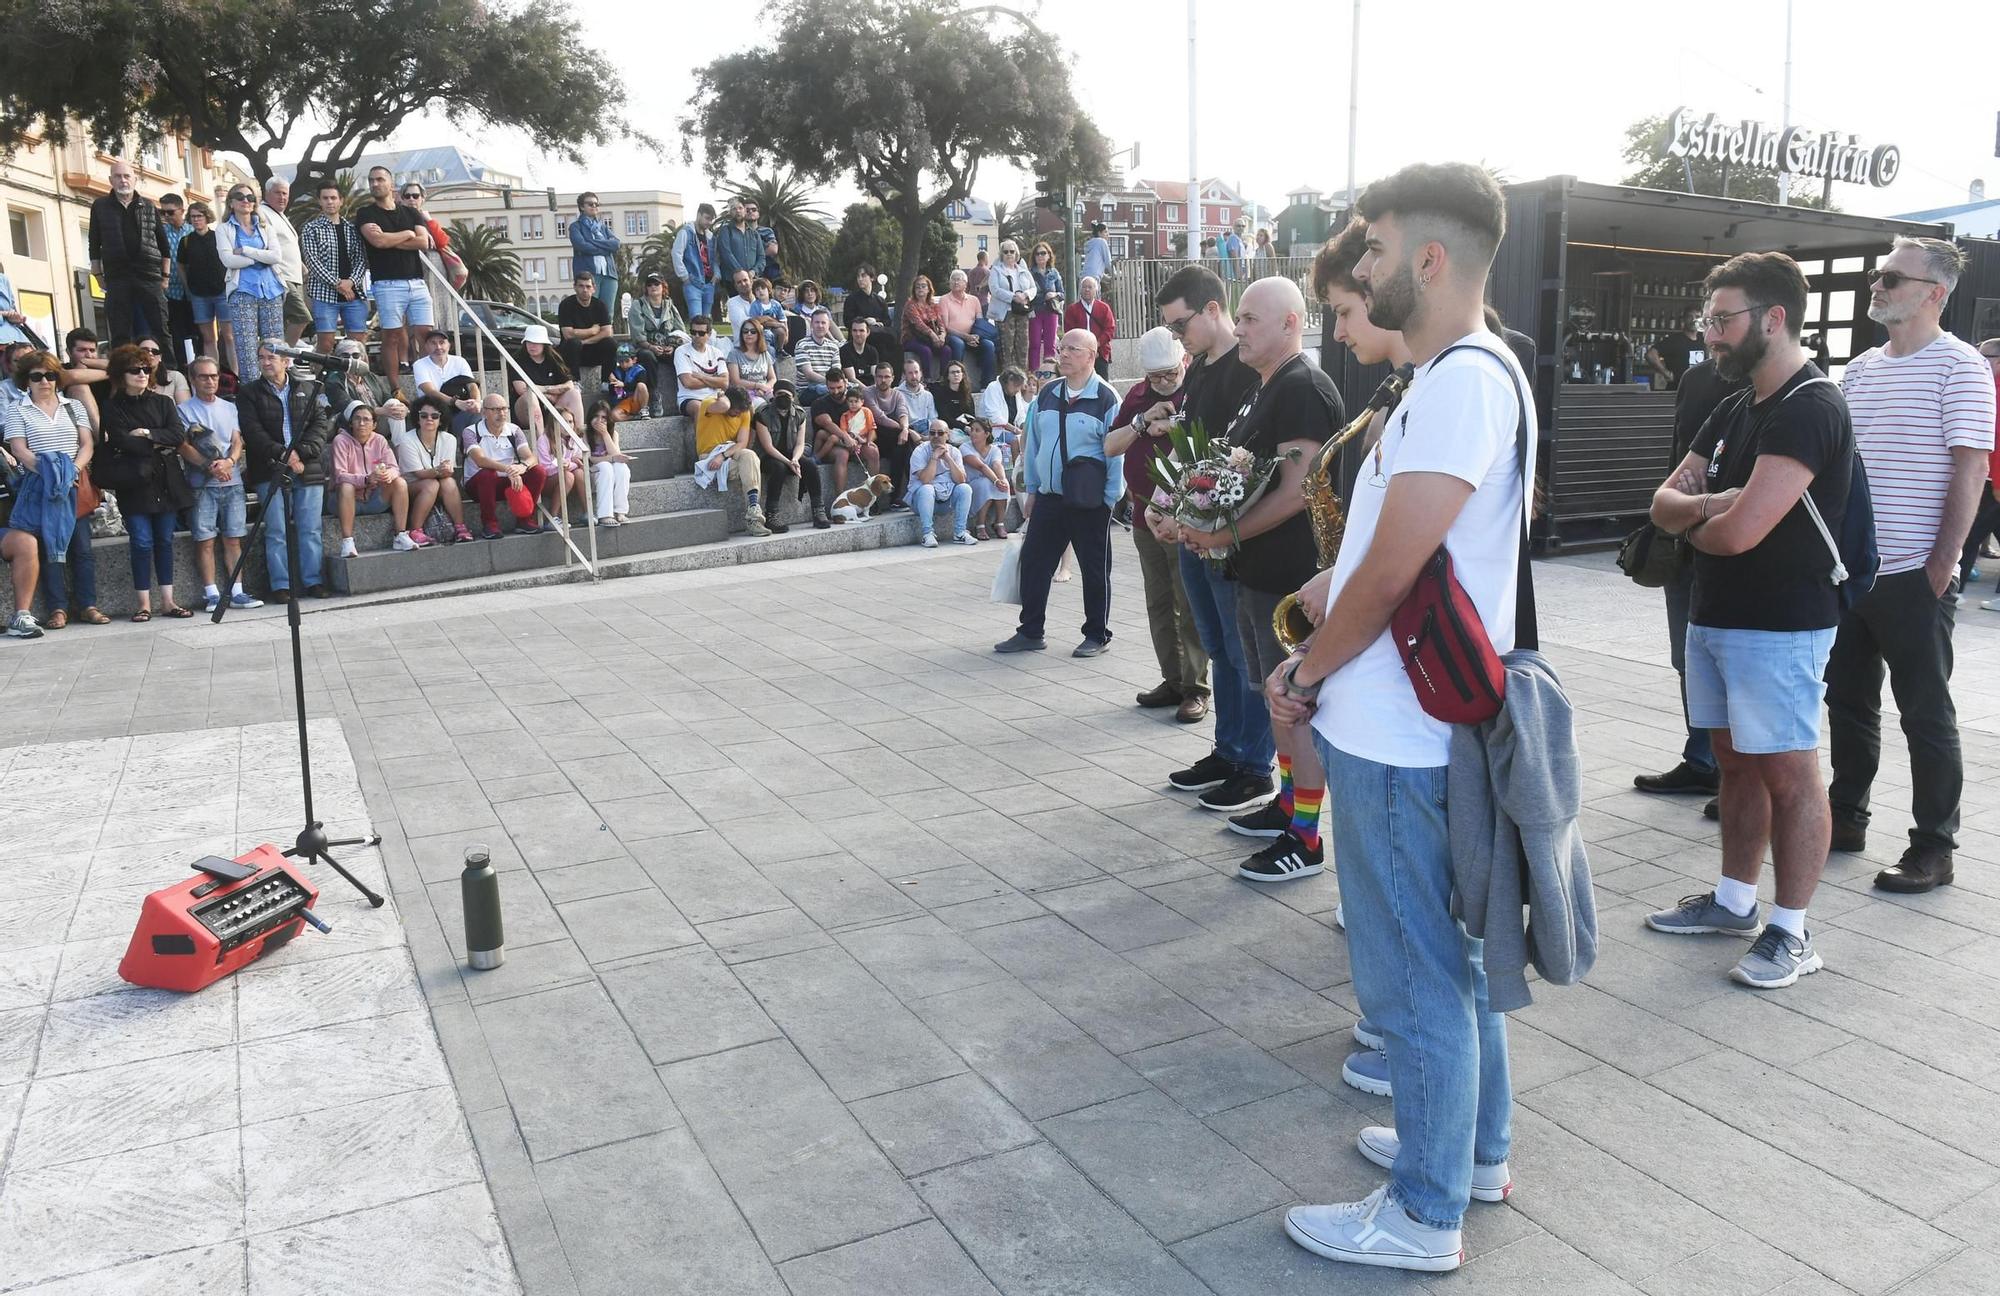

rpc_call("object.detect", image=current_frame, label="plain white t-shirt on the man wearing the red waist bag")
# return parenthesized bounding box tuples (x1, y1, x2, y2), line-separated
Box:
(1312, 330, 1536, 770)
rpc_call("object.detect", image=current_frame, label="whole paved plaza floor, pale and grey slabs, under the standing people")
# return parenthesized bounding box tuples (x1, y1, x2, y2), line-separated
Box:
(0, 536, 2000, 1296)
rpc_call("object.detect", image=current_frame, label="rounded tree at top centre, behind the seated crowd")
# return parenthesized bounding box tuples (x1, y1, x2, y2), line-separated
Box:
(680, 0, 1110, 298)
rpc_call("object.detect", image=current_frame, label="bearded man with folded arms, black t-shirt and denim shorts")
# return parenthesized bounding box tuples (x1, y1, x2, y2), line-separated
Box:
(1646, 252, 1860, 990)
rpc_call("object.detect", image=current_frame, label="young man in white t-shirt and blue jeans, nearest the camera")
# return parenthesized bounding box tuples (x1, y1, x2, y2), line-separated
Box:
(1266, 164, 1536, 1270)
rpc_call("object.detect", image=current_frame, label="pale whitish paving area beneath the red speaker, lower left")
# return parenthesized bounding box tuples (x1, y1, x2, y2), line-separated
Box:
(0, 722, 520, 1296)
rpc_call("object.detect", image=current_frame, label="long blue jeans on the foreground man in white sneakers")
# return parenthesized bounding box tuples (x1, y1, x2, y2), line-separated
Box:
(1312, 732, 1514, 1228)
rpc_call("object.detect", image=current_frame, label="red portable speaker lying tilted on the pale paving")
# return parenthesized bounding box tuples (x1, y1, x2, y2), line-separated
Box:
(118, 846, 326, 990)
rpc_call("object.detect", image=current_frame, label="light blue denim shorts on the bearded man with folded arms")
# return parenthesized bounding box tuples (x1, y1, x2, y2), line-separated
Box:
(1688, 626, 1834, 756)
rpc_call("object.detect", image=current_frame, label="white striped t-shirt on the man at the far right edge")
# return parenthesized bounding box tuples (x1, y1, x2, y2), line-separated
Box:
(1840, 334, 1994, 576)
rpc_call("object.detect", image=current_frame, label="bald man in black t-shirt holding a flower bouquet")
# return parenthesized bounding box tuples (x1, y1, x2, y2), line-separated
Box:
(1182, 276, 1352, 880)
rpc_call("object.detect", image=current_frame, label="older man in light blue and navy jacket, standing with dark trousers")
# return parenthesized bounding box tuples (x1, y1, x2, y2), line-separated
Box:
(994, 328, 1128, 656)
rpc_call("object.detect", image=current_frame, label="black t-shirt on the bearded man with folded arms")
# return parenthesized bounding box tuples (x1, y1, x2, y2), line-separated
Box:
(1690, 364, 1854, 630)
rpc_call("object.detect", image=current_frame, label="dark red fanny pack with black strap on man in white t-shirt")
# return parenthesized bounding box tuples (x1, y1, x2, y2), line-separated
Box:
(1388, 344, 1538, 724)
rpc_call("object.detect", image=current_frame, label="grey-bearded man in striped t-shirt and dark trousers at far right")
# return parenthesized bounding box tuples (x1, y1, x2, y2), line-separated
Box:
(1826, 238, 1994, 892)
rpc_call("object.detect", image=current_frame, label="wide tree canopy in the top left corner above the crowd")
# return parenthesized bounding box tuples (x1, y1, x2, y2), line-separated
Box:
(0, 0, 658, 190)
